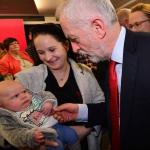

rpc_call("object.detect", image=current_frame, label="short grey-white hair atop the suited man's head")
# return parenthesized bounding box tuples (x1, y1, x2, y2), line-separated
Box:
(56, 0, 117, 25)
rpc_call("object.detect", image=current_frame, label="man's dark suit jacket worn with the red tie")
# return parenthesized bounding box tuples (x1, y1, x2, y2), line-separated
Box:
(88, 30, 150, 150)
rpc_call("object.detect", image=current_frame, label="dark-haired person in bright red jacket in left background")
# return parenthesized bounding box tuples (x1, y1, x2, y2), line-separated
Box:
(0, 37, 33, 79)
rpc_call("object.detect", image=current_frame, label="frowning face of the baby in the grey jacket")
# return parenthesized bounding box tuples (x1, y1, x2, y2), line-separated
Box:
(2, 82, 32, 112)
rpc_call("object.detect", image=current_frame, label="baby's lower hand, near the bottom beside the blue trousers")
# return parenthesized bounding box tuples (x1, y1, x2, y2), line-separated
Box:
(33, 130, 45, 144)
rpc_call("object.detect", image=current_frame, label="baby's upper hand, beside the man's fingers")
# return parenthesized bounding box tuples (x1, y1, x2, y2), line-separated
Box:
(42, 101, 53, 116)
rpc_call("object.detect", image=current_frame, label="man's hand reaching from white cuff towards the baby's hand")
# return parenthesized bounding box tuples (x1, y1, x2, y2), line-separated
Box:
(54, 103, 79, 122)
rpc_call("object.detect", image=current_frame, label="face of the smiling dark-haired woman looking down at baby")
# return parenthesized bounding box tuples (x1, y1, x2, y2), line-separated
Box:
(34, 34, 67, 70)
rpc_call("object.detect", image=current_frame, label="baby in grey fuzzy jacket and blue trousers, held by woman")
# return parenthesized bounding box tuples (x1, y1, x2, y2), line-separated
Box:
(0, 80, 78, 150)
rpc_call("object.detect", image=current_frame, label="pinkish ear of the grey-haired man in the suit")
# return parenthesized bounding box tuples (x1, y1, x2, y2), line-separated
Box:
(92, 19, 106, 39)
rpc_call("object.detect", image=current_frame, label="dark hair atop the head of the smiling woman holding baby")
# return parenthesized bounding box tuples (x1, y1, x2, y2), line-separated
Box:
(32, 23, 67, 43)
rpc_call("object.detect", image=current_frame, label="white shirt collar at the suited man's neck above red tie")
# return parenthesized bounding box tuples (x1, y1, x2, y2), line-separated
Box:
(111, 27, 126, 64)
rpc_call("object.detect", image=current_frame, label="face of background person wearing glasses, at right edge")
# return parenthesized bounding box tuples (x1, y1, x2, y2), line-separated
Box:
(129, 11, 150, 32)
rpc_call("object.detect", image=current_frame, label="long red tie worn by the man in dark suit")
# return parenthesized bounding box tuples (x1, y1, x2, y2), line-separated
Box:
(109, 60, 120, 150)
